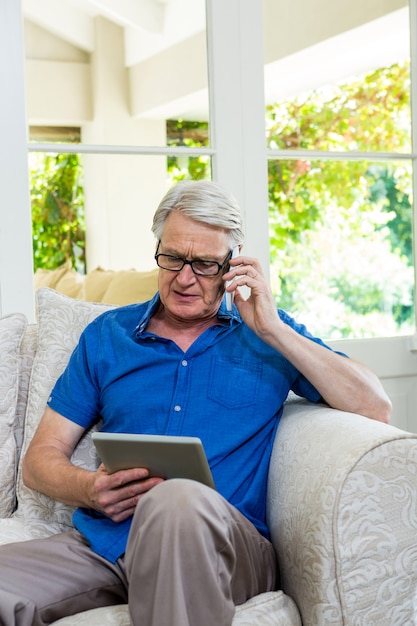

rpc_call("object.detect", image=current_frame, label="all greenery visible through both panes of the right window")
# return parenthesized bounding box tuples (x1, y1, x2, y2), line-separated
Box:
(267, 63, 414, 337)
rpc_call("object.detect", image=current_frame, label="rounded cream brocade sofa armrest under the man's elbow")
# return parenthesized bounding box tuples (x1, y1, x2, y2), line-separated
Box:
(268, 400, 417, 626)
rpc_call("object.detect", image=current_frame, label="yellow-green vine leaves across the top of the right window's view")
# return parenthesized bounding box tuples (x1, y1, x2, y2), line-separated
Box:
(266, 64, 410, 249)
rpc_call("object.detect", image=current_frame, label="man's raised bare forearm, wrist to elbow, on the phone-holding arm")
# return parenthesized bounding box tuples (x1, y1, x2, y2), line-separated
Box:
(267, 325, 391, 422)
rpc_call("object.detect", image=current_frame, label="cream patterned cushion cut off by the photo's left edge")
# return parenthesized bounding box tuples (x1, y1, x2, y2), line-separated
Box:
(0, 314, 27, 517)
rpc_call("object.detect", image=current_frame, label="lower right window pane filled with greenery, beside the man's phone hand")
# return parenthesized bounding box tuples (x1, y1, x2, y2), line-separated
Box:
(269, 160, 414, 339)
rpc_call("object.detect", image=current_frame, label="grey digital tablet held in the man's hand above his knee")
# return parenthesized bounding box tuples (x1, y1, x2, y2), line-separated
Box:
(92, 432, 214, 488)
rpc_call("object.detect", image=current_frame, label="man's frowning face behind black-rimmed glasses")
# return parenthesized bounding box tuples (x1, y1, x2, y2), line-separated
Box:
(158, 211, 230, 322)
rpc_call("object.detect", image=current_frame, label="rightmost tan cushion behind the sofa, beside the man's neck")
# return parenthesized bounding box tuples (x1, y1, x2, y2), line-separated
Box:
(101, 269, 158, 306)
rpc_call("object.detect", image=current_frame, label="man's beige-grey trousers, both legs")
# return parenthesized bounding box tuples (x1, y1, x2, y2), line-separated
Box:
(0, 480, 277, 626)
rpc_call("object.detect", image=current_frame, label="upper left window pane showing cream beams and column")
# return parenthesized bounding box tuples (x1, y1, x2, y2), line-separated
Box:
(23, 0, 209, 146)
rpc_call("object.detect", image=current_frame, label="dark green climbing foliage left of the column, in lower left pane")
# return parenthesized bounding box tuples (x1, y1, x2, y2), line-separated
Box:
(30, 154, 85, 272)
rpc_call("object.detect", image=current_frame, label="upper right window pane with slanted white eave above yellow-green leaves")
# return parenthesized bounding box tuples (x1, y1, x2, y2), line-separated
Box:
(265, 0, 411, 152)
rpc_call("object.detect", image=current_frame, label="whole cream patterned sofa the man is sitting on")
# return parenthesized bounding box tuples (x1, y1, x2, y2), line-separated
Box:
(0, 288, 417, 626)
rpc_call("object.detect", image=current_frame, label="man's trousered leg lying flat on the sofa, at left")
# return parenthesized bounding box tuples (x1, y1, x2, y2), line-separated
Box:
(0, 531, 127, 624)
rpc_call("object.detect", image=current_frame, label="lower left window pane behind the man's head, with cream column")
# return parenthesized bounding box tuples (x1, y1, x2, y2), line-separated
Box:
(29, 152, 211, 274)
